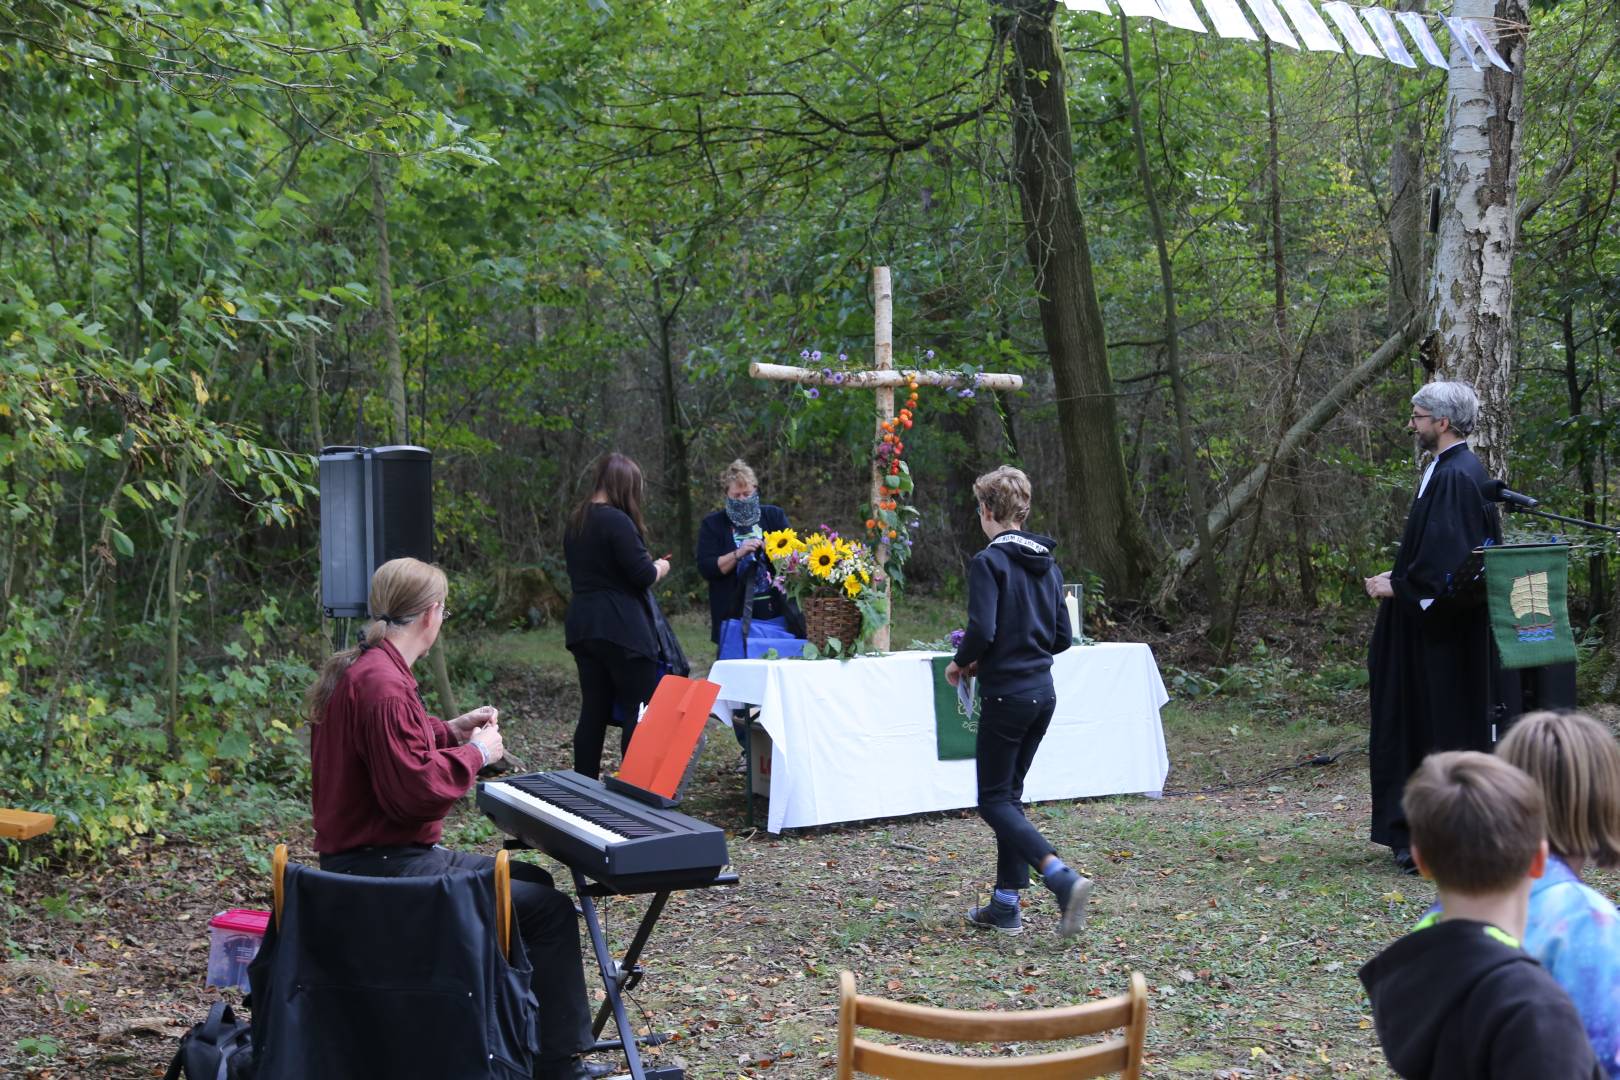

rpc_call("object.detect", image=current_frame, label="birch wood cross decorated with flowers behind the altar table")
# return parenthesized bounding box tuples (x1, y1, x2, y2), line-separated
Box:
(748, 266, 1024, 653)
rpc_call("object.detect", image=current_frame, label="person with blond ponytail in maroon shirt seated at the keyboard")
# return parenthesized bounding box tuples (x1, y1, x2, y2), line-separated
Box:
(308, 559, 595, 1080)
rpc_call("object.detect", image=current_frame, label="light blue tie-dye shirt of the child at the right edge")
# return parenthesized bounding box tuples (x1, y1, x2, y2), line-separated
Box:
(1524, 855, 1620, 1080)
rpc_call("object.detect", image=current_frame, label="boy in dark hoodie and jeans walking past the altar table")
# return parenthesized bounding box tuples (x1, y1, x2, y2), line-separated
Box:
(944, 465, 1092, 936)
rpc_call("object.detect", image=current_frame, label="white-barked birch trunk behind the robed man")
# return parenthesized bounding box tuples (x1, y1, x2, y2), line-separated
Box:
(1429, 0, 1529, 476)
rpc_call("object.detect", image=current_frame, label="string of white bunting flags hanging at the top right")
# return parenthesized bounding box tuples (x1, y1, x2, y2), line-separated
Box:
(1063, 0, 1513, 74)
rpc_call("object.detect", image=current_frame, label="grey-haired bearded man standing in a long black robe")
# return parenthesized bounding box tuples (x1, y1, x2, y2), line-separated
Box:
(1366, 382, 1502, 873)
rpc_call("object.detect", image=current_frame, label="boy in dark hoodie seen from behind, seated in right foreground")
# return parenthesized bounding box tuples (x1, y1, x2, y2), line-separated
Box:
(1361, 751, 1604, 1080)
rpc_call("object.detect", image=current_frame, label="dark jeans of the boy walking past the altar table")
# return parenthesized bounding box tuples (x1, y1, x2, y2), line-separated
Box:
(977, 687, 1058, 889)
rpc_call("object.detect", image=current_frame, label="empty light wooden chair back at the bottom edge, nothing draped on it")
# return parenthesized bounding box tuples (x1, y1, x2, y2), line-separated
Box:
(838, 972, 1147, 1080)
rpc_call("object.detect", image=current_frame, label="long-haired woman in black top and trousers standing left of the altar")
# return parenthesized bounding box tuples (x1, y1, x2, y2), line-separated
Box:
(562, 453, 669, 777)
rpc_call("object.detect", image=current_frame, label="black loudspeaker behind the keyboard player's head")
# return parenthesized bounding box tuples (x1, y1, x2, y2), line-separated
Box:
(321, 447, 433, 619)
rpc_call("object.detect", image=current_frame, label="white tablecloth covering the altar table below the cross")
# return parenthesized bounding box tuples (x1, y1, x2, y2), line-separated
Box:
(708, 643, 1170, 832)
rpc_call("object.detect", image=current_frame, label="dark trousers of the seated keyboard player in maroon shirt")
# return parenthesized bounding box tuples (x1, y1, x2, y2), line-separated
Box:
(321, 844, 596, 1062)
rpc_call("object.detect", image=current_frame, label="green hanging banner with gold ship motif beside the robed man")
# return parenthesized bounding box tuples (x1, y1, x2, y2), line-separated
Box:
(1486, 544, 1575, 667)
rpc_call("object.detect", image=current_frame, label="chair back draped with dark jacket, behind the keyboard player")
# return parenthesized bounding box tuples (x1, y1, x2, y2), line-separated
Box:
(259, 847, 538, 1080)
